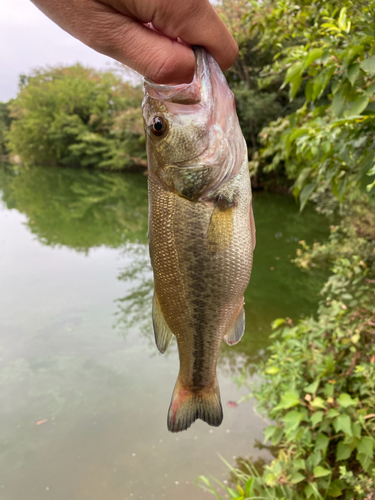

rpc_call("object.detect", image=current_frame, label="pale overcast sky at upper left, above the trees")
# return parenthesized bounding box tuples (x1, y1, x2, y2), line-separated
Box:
(0, 0, 140, 102)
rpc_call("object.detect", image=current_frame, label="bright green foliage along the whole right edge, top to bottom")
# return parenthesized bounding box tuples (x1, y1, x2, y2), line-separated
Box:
(201, 0, 375, 500)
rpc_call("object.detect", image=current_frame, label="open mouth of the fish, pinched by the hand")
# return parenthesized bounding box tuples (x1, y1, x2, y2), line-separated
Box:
(143, 46, 208, 104)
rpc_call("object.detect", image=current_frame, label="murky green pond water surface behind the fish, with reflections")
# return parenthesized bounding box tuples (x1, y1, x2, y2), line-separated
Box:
(0, 165, 328, 500)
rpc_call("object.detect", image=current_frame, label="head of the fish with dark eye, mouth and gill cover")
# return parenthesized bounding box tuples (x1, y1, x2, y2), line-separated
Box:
(143, 47, 246, 201)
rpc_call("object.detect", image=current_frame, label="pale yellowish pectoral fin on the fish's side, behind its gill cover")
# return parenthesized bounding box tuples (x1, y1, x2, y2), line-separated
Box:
(207, 200, 234, 252)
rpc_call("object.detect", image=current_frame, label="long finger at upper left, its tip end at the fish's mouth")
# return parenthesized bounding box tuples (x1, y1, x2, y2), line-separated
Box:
(33, 0, 195, 84)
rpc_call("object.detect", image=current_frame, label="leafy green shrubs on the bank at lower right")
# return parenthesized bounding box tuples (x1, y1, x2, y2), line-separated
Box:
(200, 196, 375, 500)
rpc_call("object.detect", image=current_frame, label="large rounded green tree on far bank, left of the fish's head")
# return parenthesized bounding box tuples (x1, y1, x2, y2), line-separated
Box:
(8, 65, 146, 170)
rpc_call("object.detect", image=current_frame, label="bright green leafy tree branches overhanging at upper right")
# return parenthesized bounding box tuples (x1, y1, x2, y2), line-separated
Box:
(261, 0, 375, 203)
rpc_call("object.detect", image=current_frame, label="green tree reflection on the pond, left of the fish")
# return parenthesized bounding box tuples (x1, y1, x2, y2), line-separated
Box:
(0, 166, 147, 252)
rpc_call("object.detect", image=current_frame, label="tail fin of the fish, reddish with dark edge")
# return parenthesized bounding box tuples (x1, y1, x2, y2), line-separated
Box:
(168, 379, 223, 432)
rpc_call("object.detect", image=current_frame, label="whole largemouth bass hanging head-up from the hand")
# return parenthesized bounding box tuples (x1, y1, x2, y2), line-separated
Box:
(142, 47, 255, 432)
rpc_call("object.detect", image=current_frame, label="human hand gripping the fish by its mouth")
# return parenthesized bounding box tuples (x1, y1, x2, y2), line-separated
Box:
(32, 0, 238, 84)
